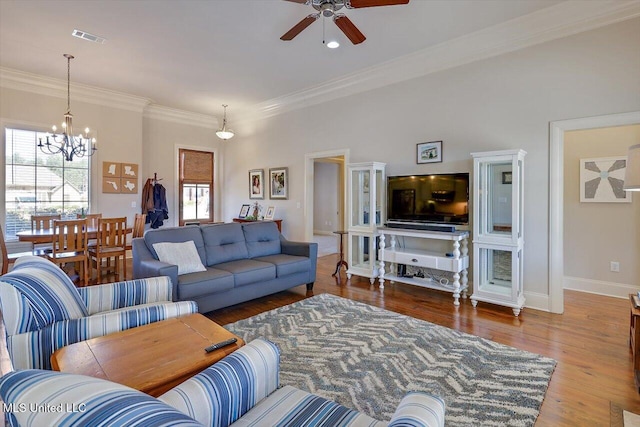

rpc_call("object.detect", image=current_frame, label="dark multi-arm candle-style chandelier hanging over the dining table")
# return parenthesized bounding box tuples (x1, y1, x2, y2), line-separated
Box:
(38, 53, 98, 162)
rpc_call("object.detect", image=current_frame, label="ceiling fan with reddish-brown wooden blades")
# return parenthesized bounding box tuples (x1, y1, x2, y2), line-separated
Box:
(280, 0, 409, 44)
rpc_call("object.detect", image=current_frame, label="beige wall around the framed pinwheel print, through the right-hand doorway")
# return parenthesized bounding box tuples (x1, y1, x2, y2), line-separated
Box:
(564, 125, 640, 297)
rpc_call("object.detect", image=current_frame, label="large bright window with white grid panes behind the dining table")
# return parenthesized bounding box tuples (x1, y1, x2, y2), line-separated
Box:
(4, 128, 91, 240)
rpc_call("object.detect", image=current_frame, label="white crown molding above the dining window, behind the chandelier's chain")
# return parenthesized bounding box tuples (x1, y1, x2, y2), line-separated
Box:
(0, 67, 151, 113)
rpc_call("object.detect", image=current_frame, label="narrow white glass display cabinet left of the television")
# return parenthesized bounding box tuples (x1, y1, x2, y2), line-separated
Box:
(347, 162, 386, 284)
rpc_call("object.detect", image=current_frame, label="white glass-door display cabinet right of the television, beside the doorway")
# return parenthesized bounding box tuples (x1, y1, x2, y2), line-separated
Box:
(471, 150, 526, 316)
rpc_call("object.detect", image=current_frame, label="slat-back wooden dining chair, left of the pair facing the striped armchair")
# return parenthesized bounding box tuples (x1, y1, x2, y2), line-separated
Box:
(47, 219, 89, 286)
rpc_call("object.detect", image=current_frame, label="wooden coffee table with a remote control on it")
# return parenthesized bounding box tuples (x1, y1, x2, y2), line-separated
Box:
(51, 314, 244, 397)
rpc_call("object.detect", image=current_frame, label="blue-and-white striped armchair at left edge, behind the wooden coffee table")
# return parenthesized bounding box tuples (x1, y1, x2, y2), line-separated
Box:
(0, 256, 198, 369)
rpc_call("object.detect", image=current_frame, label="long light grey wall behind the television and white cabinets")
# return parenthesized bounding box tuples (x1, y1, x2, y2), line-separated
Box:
(225, 19, 640, 308)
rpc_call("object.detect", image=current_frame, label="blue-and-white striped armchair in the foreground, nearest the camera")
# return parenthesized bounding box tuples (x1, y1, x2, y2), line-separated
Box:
(0, 339, 445, 427)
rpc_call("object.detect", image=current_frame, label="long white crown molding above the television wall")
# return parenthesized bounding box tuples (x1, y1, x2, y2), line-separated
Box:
(242, 0, 640, 121)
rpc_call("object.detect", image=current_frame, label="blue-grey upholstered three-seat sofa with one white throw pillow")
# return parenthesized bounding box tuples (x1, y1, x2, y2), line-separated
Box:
(132, 221, 318, 313)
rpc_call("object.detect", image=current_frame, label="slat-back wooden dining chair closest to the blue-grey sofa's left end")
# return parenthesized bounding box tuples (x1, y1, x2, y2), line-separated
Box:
(89, 217, 127, 284)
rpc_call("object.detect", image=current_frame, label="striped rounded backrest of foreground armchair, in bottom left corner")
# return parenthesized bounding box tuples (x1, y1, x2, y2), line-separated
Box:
(0, 370, 202, 427)
